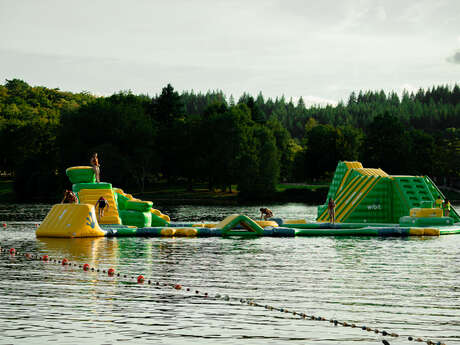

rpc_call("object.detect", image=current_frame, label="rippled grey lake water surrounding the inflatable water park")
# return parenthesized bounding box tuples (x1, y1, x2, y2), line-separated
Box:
(0, 204, 460, 345)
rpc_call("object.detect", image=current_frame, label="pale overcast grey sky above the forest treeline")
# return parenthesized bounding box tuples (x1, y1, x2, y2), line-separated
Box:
(0, 0, 460, 103)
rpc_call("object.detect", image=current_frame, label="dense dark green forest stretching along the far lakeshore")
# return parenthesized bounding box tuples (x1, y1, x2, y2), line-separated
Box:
(0, 79, 460, 200)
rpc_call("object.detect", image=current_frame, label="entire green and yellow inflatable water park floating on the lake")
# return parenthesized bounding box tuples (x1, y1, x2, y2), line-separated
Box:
(36, 162, 460, 238)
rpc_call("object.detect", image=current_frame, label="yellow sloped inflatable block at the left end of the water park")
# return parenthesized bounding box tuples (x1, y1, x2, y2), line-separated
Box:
(36, 204, 105, 238)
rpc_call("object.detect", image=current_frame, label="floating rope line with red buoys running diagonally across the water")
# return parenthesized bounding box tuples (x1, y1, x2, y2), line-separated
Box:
(0, 247, 446, 345)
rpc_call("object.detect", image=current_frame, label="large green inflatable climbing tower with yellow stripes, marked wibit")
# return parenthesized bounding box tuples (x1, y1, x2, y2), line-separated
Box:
(317, 162, 460, 223)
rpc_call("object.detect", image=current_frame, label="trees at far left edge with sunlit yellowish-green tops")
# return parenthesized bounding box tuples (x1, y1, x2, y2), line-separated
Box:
(0, 79, 95, 200)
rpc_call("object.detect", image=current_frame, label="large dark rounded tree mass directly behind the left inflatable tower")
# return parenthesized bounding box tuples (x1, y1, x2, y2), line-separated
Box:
(59, 93, 159, 190)
